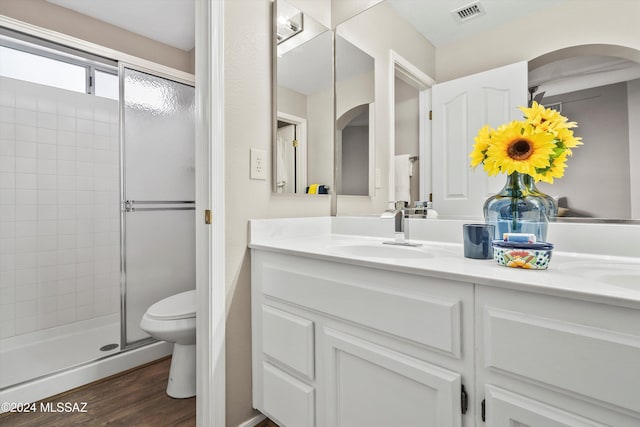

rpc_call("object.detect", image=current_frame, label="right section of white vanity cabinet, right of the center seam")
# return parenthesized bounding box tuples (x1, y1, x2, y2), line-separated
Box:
(475, 286, 640, 427)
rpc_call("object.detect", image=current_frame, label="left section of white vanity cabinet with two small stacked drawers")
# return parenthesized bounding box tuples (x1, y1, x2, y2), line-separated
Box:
(251, 249, 475, 427)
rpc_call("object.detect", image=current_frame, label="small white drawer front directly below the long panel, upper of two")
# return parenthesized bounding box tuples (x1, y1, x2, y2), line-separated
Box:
(262, 305, 314, 381)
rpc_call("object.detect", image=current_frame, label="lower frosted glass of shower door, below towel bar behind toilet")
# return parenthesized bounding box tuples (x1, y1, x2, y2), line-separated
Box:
(125, 211, 196, 343)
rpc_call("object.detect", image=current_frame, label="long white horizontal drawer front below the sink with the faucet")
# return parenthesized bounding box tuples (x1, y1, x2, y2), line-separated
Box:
(257, 259, 464, 359)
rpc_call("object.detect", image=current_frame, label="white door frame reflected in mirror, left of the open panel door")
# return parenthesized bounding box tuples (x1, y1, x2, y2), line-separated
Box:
(388, 49, 436, 201)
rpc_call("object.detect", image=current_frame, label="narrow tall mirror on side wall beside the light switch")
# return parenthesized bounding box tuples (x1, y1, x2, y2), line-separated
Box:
(272, 0, 334, 194)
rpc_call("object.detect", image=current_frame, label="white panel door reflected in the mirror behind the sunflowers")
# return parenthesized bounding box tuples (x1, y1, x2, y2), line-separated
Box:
(432, 61, 527, 217)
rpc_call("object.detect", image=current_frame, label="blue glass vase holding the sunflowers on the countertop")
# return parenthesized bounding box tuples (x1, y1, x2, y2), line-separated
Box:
(483, 172, 558, 242)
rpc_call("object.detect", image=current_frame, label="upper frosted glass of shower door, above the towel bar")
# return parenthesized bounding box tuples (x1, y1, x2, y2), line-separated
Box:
(124, 69, 195, 200)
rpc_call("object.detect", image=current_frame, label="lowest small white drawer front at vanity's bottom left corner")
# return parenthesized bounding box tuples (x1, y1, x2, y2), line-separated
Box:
(262, 363, 315, 427)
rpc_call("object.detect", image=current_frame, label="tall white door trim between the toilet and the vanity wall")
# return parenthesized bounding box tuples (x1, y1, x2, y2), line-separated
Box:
(195, 0, 226, 427)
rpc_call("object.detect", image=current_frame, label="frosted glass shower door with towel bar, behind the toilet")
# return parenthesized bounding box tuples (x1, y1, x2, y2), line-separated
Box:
(120, 65, 196, 348)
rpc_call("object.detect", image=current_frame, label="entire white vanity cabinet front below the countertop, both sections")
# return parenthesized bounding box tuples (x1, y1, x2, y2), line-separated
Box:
(252, 249, 640, 427)
